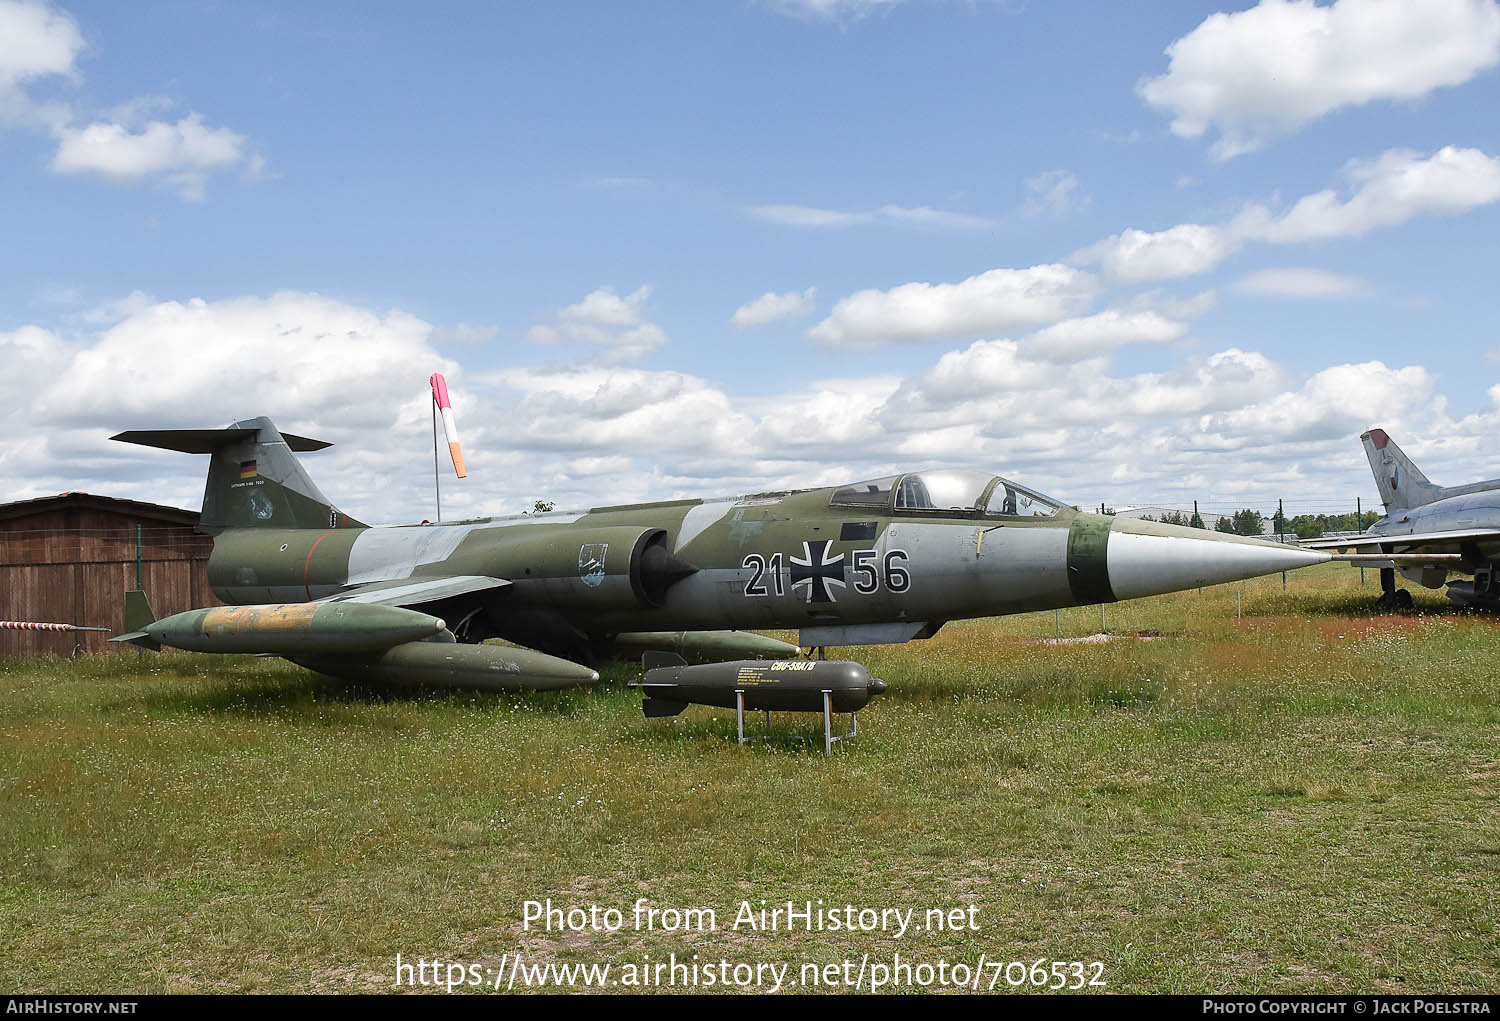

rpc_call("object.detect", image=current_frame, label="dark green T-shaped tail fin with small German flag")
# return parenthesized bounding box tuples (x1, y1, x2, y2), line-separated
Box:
(111, 418, 365, 535)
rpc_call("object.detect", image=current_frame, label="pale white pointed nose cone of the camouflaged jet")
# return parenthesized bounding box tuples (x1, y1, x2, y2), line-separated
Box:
(1107, 532, 1331, 600)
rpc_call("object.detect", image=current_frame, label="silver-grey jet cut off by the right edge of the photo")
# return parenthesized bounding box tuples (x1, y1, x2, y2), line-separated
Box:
(1302, 429, 1500, 610)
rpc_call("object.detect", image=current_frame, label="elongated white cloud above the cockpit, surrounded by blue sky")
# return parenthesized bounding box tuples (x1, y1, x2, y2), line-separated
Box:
(807, 264, 1097, 348)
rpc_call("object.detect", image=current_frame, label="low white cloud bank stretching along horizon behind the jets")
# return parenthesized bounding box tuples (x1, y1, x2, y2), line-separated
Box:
(0, 292, 1482, 522)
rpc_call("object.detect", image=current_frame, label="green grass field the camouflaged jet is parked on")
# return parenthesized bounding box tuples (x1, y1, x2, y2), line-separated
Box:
(0, 565, 1500, 993)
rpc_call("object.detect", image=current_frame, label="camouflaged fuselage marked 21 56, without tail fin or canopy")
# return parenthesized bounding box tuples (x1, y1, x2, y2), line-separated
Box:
(209, 489, 1314, 637)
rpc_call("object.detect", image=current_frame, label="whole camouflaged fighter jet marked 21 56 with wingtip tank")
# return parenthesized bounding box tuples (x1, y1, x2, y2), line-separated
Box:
(114, 418, 1331, 688)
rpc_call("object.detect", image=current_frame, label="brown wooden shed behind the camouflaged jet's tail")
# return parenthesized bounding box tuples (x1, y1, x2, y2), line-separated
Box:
(0, 493, 219, 657)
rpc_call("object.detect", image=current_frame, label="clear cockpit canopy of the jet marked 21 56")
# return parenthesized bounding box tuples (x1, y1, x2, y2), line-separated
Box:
(828, 468, 1062, 517)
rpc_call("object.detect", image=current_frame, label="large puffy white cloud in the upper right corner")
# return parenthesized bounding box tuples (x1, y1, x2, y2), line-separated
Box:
(1137, 0, 1500, 160)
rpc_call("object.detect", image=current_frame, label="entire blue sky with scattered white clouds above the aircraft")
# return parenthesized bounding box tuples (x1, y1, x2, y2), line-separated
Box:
(0, 0, 1500, 523)
